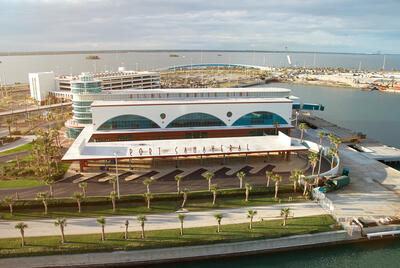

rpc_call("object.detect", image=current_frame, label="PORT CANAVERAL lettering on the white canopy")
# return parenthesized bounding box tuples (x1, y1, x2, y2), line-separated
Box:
(127, 144, 250, 157)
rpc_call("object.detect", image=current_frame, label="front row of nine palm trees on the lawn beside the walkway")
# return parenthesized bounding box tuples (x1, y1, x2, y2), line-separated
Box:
(14, 208, 291, 246)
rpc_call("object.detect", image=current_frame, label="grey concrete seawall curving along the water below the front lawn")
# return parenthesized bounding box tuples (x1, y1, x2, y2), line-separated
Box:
(1, 231, 350, 268)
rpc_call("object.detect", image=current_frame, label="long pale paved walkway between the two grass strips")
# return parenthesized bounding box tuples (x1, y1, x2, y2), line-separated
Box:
(0, 202, 327, 238)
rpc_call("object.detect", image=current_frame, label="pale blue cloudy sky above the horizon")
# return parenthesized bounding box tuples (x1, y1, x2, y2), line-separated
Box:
(0, 0, 400, 54)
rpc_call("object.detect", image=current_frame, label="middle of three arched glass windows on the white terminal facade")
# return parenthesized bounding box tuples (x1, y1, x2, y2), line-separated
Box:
(167, 113, 226, 128)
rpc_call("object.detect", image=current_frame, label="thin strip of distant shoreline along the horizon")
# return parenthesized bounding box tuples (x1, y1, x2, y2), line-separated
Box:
(0, 49, 392, 56)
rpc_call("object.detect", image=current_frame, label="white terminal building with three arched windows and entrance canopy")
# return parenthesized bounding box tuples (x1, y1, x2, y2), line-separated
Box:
(63, 74, 307, 171)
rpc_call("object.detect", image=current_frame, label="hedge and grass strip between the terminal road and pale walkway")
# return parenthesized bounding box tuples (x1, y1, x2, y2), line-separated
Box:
(0, 184, 305, 220)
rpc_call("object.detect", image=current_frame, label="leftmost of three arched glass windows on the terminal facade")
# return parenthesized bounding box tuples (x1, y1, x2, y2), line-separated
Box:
(98, 114, 160, 130)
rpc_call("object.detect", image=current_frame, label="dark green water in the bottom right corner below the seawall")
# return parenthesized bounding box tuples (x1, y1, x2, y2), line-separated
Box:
(154, 240, 400, 268)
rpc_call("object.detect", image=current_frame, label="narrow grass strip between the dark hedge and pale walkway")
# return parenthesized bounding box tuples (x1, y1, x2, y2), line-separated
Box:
(0, 193, 305, 220)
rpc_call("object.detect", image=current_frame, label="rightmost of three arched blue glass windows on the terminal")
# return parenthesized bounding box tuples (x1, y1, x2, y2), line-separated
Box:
(232, 112, 287, 126)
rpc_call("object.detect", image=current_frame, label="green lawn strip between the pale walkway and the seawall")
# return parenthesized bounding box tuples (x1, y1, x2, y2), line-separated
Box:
(0, 215, 337, 257)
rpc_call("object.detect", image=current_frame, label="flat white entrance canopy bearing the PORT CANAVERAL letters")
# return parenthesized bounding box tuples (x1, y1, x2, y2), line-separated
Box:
(62, 127, 307, 161)
